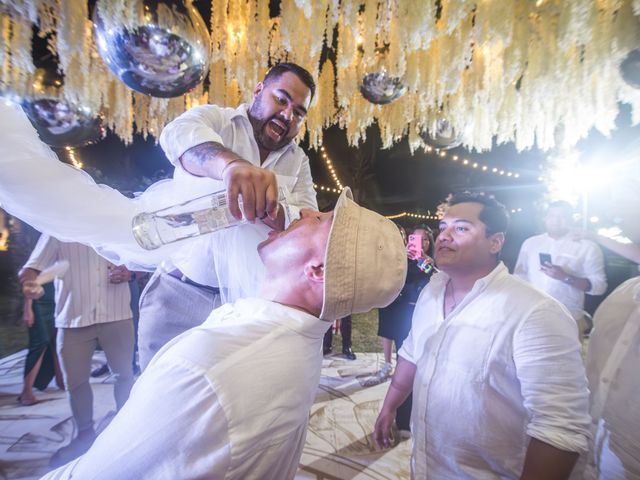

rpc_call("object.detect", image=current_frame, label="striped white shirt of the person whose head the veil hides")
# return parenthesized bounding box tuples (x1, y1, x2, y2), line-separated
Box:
(24, 235, 133, 328)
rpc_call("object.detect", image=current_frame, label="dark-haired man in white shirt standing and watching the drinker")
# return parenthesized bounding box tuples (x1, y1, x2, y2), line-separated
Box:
(374, 193, 590, 480)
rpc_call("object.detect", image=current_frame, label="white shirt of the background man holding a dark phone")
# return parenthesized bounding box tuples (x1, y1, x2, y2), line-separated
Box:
(513, 233, 607, 320)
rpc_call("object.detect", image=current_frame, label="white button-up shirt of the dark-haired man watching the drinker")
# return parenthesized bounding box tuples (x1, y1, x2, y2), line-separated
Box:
(399, 264, 590, 479)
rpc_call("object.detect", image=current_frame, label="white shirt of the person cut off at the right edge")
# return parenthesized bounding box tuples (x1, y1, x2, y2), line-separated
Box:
(584, 277, 640, 480)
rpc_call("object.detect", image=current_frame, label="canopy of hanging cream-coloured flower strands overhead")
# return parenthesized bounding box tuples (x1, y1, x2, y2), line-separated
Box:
(0, 0, 640, 150)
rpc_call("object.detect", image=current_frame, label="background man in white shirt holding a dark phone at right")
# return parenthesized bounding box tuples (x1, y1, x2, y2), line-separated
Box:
(513, 201, 607, 332)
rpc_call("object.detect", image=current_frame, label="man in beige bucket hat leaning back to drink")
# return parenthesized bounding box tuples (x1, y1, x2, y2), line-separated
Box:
(45, 188, 406, 480)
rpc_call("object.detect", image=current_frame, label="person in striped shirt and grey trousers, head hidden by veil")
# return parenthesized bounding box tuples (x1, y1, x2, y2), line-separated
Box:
(21, 234, 134, 467)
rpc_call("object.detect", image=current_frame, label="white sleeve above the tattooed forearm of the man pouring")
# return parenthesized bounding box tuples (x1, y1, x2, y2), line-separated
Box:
(160, 105, 224, 167)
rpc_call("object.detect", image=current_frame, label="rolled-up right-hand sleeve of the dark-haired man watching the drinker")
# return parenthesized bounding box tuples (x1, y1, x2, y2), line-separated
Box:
(513, 305, 591, 452)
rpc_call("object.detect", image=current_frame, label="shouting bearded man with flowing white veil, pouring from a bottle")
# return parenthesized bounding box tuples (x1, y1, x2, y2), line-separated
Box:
(0, 63, 317, 368)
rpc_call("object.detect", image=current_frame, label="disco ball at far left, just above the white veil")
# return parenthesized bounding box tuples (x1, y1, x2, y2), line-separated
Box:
(20, 69, 105, 147)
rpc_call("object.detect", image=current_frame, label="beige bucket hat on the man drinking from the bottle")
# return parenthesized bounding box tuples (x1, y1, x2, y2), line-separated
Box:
(320, 187, 407, 321)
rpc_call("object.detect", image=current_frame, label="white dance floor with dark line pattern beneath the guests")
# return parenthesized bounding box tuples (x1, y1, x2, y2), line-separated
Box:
(0, 351, 411, 480)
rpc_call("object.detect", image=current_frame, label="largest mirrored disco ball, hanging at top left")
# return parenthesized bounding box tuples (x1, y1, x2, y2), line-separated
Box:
(93, 0, 209, 98)
